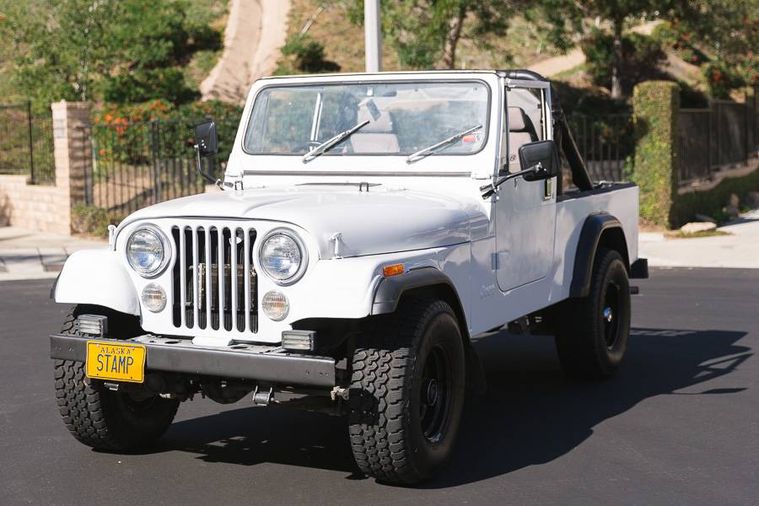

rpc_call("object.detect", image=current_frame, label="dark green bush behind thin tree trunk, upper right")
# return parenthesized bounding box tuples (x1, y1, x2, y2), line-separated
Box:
(580, 29, 665, 95)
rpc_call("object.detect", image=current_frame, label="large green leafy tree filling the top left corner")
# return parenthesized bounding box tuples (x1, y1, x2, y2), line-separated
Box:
(0, 0, 221, 105)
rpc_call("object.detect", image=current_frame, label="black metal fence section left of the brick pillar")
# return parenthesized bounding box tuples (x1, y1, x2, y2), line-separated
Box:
(0, 103, 55, 184)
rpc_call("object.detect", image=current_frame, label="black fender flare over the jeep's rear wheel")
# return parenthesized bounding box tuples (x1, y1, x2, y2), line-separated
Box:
(569, 213, 630, 297)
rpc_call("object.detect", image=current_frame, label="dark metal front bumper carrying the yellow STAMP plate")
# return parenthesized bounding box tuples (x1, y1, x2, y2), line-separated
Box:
(50, 334, 335, 387)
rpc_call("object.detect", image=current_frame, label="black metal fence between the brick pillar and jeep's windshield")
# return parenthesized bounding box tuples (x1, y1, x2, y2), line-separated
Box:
(80, 118, 238, 215)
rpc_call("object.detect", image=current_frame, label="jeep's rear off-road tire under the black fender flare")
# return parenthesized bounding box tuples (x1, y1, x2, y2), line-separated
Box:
(556, 248, 630, 379)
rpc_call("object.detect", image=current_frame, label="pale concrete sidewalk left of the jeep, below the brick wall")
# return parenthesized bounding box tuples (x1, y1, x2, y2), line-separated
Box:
(0, 227, 108, 281)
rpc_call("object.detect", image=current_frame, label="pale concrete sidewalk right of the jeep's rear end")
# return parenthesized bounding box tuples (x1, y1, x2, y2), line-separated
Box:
(639, 209, 759, 269)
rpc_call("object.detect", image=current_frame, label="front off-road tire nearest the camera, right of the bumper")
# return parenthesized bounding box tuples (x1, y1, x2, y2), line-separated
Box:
(349, 299, 466, 485)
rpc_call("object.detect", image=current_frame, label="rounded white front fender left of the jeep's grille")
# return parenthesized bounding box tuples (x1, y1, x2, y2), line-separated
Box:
(52, 249, 140, 316)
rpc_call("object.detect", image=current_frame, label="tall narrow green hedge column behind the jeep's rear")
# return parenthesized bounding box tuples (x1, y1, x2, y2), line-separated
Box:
(633, 81, 679, 227)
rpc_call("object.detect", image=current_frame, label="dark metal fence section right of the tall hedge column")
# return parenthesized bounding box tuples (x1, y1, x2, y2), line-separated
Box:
(678, 89, 759, 184)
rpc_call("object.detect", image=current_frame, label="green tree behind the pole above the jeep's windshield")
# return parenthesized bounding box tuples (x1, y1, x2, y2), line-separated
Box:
(349, 0, 530, 69)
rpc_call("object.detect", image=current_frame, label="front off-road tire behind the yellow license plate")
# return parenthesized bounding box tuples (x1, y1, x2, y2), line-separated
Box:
(54, 306, 179, 452)
